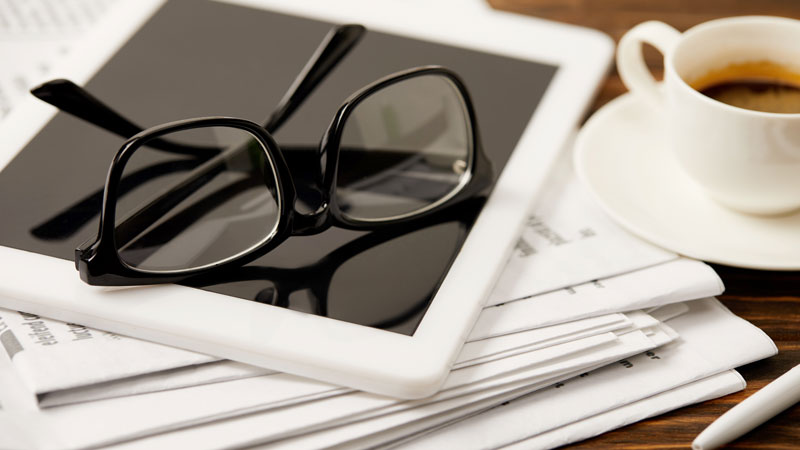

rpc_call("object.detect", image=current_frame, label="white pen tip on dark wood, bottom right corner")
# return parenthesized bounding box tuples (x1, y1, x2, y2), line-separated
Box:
(692, 365, 800, 450)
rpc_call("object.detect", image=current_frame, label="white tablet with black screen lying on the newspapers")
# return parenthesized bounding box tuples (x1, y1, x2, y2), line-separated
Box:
(0, 0, 613, 398)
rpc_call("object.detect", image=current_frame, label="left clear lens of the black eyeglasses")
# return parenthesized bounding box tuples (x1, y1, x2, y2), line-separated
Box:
(115, 127, 280, 272)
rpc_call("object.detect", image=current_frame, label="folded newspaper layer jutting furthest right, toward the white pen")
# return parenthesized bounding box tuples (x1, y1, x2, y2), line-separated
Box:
(388, 299, 778, 449)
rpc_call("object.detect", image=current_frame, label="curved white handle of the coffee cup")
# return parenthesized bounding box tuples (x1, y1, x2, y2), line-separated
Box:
(617, 20, 681, 108)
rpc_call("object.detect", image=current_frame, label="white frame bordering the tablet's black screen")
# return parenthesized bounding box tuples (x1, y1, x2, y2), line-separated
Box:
(0, 0, 613, 398)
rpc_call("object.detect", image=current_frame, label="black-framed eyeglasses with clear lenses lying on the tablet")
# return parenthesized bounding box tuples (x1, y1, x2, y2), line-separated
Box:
(32, 25, 492, 285)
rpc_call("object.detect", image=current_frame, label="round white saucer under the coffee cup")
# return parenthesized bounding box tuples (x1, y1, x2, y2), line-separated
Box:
(575, 89, 800, 270)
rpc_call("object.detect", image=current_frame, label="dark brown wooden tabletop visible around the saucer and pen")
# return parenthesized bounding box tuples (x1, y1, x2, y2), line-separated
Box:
(489, 0, 800, 449)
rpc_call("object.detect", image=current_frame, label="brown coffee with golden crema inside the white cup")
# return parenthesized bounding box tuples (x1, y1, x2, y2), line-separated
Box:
(690, 61, 800, 114)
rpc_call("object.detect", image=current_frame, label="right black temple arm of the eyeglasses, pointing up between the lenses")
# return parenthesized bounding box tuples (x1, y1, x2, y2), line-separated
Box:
(264, 25, 366, 133)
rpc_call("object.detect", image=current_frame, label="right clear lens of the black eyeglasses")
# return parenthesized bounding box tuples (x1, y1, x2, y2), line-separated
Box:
(336, 74, 473, 221)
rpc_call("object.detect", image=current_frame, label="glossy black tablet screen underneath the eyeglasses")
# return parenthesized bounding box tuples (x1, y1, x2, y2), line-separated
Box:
(0, 0, 556, 335)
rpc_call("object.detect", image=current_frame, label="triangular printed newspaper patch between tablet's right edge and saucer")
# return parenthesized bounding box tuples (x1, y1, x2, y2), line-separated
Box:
(488, 155, 678, 305)
